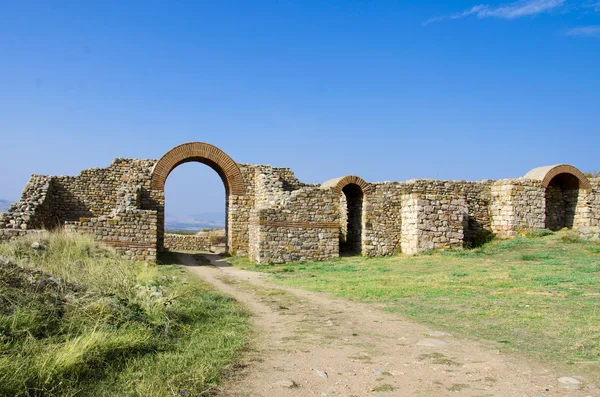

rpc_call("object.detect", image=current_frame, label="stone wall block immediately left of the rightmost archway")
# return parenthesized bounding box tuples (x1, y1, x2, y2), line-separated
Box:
(490, 179, 546, 237)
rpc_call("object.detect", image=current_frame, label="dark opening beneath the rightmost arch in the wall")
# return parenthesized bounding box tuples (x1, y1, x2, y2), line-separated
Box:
(546, 173, 580, 230)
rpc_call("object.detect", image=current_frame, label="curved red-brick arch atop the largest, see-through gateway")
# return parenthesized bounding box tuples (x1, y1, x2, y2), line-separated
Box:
(150, 142, 246, 196)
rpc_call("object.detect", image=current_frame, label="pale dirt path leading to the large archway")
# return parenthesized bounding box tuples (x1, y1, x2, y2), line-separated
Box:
(180, 254, 600, 397)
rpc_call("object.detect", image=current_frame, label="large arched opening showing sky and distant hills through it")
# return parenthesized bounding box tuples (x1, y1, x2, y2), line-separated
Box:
(164, 162, 228, 252)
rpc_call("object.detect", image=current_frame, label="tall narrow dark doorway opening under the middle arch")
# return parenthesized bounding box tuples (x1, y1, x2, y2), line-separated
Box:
(340, 183, 364, 255)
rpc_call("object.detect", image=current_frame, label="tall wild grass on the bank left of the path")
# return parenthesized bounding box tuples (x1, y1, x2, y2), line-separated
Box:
(0, 234, 249, 396)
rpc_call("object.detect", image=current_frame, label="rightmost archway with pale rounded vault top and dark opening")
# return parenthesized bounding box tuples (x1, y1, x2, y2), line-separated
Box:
(525, 164, 591, 230)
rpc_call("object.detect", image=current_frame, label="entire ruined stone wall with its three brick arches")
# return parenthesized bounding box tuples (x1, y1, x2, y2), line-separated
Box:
(0, 142, 600, 263)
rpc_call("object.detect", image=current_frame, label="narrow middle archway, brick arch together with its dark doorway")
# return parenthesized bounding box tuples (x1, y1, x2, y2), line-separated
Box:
(321, 175, 371, 255)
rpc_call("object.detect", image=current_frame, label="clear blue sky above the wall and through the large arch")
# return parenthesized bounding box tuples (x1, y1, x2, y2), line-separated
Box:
(0, 0, 600, 214)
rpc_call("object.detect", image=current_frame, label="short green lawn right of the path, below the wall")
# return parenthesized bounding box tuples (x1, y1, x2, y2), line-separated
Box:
(231, 231, 600, 373)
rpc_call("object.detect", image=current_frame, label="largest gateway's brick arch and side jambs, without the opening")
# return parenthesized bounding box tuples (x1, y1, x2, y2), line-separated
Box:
(150, 142, 246, 251)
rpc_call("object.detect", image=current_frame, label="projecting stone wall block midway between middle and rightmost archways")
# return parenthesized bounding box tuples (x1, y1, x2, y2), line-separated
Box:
(401, 193, 468, 255)
